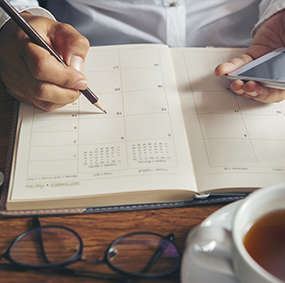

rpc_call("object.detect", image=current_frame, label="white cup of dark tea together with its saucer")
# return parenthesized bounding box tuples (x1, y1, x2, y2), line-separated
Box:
(181, 183, 285, 283)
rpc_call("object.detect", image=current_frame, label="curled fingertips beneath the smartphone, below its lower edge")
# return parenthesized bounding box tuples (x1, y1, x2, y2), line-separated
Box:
(227, 80, 285, 103)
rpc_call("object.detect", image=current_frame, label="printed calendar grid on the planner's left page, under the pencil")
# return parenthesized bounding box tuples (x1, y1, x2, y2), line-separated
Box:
(27, 47, 178, 179)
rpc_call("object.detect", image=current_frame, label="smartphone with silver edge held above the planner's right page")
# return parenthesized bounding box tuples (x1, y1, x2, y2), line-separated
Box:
(227, 47, 285, 89)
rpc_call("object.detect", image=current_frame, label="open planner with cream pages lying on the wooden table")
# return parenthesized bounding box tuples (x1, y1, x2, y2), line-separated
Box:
(1, 44, 285, 215)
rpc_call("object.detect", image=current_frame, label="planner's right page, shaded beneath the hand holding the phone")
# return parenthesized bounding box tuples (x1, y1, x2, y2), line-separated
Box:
(171, 48, 285, 192)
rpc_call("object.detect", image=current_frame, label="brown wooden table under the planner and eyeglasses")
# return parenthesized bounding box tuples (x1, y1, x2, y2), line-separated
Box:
(0, 82, 221, 283)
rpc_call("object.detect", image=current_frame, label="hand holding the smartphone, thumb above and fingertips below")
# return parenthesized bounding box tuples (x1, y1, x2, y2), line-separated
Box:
(215, 10, 285, 103)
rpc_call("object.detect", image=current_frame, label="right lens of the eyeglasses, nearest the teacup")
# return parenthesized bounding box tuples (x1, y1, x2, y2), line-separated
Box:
(106, 234, 180, 276)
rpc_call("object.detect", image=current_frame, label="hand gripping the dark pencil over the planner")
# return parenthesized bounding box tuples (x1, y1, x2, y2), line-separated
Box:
(0, 12, 89, 111)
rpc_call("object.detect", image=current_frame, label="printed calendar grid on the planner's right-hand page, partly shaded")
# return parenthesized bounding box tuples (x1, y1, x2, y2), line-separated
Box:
(183, 50, 285, 173)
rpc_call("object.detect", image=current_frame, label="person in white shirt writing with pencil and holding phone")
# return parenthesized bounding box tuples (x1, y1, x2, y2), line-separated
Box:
(0, 0, 285, 111)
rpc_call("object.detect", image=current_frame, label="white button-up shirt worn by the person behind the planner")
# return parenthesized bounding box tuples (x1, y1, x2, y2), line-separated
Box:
(0, 0, 285, 47)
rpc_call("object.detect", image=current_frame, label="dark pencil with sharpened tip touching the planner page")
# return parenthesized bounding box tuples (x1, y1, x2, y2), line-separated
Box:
(0, 0, 107, 113)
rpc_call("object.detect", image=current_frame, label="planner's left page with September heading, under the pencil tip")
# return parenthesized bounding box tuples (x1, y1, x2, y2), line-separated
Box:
(8, 45, 196, 207)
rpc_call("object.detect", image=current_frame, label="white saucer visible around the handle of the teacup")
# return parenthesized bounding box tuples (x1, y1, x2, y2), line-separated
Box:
(181, 200, 243, 283)
